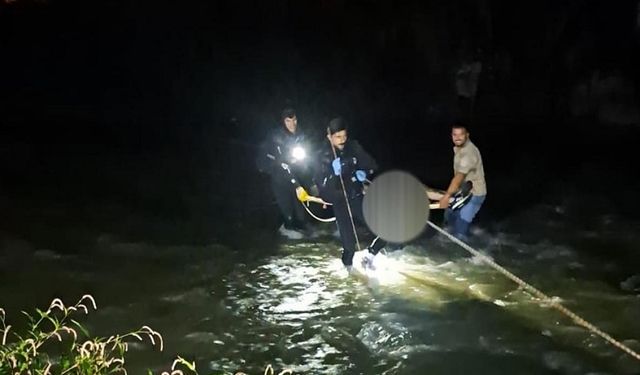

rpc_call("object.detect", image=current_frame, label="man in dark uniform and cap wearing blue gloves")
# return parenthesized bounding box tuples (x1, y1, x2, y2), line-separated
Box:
(313, 118, 386, 269)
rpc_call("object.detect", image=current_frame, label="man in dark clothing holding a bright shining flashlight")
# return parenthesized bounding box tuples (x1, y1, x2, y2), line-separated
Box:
(256, 108, 311, 239)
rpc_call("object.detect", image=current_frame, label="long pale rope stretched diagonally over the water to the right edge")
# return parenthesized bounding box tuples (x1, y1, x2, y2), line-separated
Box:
(427, 221, 640, 361)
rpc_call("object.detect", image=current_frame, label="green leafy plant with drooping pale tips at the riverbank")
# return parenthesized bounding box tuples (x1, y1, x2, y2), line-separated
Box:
(0, 295, 163, 375)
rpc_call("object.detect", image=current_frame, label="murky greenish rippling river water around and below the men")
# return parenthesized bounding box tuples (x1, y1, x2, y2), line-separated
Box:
(0, 216, 640, 374)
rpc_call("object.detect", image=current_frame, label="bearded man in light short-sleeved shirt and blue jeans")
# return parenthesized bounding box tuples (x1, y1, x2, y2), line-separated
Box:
(440, 122, 487, 241)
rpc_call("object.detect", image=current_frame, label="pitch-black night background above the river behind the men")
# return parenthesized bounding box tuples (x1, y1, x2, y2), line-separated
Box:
(0, 0, 640, 248)
